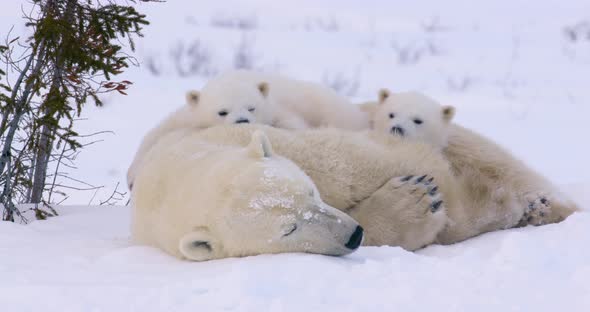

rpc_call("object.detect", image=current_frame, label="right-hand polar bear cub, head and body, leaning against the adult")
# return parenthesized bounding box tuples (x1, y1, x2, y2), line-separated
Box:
(360, 89, 579, 242)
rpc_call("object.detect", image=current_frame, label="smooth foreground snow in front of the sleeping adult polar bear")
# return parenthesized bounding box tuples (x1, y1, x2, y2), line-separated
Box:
(0, 206, 590, 311)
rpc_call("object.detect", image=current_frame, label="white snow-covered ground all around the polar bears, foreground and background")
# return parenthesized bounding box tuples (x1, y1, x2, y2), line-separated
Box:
(0, 0, 590, 311)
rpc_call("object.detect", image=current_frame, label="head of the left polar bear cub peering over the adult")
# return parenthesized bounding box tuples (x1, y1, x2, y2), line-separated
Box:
(186, 80, 272, 128)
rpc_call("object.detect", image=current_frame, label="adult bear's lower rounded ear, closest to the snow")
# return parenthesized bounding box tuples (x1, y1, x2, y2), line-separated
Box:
(178, 227, 222, 261)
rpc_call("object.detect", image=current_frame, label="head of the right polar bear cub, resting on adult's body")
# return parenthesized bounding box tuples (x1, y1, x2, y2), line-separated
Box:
(371, 89, 455, 148)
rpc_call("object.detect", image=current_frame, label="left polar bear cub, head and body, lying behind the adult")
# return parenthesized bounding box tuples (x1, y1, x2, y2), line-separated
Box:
(127, 70, 369, 186)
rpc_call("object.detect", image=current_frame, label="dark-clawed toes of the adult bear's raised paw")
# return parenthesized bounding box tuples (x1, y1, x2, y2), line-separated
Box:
(395, 175, 444, 213)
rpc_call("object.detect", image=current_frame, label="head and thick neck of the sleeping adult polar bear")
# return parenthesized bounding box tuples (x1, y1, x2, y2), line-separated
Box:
(132, 130, 362, 261)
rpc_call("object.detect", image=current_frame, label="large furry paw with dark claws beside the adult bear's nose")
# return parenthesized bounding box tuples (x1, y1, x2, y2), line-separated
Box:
(348, 175, 448, 250)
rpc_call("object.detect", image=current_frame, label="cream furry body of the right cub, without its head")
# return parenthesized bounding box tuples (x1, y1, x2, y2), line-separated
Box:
(440, 124, 579, 241)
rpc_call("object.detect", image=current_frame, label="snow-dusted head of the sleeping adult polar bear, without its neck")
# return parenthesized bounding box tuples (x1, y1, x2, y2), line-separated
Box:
(179, 131, 363, 261)
